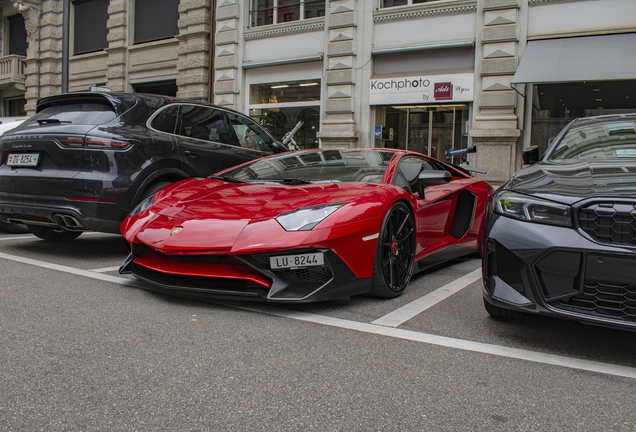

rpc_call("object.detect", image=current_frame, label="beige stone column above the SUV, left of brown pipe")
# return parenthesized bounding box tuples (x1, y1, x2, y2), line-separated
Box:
(177, 0, 210, 101)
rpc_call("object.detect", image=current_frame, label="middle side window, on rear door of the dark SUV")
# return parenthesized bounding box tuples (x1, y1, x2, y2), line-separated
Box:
(176, 104, 234, 145)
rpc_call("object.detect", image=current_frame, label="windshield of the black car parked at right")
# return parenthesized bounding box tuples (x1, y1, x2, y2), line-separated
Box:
(548, 117, 636, 161)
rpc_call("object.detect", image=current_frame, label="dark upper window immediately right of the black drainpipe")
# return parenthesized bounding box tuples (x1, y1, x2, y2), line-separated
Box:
(73, 0, 109, 55)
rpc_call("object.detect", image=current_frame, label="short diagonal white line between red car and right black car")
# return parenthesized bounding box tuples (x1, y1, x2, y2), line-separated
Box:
(371, 268, 481, 327)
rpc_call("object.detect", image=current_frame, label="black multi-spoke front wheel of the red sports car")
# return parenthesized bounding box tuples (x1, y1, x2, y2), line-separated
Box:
(371, 202, 415, 298)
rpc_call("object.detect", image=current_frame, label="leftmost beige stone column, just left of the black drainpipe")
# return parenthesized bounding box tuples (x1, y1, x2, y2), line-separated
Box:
(21, 0, 63, 115)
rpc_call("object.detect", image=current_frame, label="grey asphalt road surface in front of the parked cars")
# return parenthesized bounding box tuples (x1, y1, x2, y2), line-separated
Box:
(0, 234, 636, 431)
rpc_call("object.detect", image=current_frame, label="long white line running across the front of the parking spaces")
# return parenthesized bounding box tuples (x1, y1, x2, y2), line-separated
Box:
(0, 253, 636, 378)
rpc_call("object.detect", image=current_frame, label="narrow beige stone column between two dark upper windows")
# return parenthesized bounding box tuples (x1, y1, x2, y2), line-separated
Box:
(106, 0, 130, 91)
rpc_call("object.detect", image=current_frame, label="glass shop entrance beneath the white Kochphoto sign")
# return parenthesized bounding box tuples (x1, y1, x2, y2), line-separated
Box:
(375, 104, 469, 160)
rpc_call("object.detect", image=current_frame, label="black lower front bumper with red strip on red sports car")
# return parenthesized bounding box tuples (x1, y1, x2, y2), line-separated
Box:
(119, 243, 371, 302)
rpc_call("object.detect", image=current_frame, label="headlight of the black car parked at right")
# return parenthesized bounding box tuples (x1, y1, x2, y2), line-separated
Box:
(495, 192, 572, 227)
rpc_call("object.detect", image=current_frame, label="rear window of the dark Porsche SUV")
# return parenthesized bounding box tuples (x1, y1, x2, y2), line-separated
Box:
(25, 102, 117, 125)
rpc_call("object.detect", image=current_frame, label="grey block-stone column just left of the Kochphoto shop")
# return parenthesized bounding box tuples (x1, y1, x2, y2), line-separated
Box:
(318, 0, 358, 148)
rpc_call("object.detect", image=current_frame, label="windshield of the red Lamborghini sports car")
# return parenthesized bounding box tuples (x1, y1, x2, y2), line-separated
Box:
(223, 150, 394, 183)
